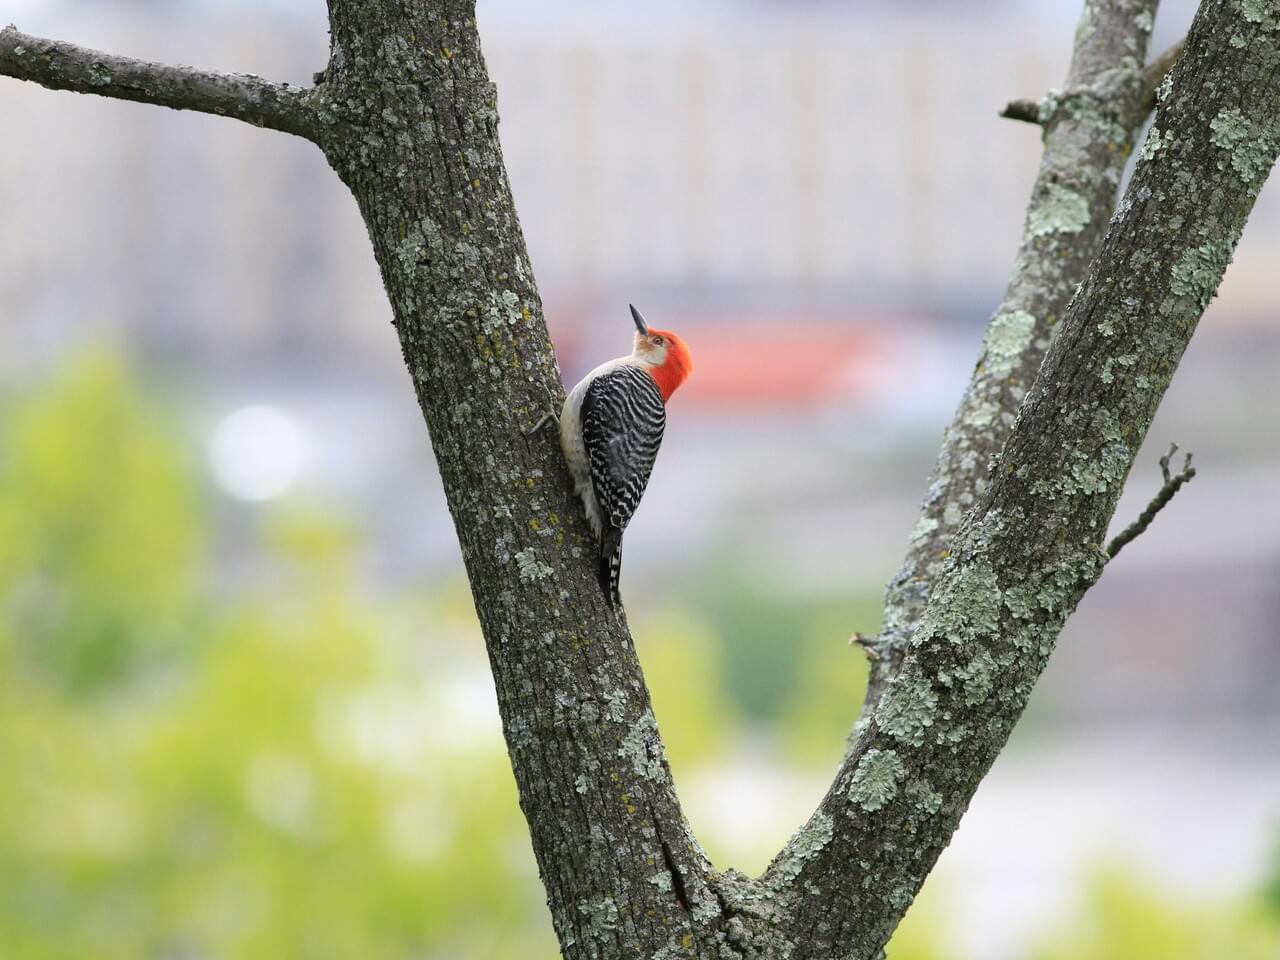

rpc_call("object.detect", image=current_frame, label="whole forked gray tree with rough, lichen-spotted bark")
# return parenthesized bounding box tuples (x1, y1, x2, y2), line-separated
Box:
(0, 0, 1280, 960)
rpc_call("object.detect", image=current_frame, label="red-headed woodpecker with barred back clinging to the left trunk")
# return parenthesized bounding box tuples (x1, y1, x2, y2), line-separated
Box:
(561, 307, 694, 607)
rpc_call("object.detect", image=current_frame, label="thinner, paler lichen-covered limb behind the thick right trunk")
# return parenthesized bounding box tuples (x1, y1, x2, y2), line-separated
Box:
(863, 0, 1169, 717)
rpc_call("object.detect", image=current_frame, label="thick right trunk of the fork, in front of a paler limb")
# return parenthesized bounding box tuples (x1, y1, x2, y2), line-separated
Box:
(767, 0, 1280, 960)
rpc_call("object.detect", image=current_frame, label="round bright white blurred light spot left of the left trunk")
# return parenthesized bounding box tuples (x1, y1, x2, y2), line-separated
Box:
(209, 407, 306, 500)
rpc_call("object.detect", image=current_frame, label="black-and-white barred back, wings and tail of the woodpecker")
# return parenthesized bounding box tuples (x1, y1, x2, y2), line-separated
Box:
(575, 364, 667, 605)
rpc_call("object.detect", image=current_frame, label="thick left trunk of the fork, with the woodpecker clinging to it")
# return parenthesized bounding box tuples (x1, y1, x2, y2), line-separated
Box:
(315, 0, 728, 960)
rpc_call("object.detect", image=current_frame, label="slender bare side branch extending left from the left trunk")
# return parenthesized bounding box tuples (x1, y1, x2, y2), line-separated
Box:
(0, 24, 315, 140)
